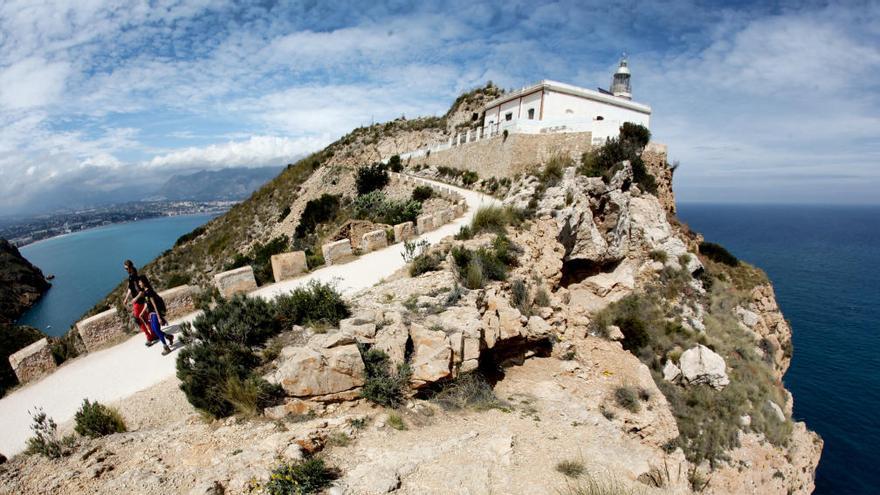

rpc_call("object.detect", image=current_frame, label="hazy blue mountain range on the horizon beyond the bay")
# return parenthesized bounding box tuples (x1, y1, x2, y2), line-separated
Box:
(156, 167, 282, 201)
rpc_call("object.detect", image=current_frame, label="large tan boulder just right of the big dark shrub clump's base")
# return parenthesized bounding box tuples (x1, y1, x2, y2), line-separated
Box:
(266, 339, 365, 397)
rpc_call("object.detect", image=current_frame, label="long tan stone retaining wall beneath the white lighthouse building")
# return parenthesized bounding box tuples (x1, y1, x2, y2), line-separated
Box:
(409, 132, 592, 178)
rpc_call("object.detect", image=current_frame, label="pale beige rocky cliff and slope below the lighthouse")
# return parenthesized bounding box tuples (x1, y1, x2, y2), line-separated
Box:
(0, 87, 822, 495)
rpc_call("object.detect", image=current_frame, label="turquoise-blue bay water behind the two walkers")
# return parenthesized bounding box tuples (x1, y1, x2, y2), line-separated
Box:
(19, 214, 214, 335)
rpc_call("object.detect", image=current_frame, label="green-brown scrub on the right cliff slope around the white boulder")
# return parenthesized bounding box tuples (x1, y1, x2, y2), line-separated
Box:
(593, 246, 792, 464)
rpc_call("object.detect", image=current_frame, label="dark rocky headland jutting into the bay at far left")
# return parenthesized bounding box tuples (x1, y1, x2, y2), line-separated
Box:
(0, 239, 50, 323)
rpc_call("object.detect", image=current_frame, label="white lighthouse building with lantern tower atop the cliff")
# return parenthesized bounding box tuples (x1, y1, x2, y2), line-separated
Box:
(480, 56, 651, 144)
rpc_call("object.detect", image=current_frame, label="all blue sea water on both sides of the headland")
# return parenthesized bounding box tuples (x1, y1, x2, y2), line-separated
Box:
(10, 203, 880, 495)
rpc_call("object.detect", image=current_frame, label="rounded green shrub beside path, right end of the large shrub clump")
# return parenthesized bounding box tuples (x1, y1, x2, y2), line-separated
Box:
(275, 280, 351, 328)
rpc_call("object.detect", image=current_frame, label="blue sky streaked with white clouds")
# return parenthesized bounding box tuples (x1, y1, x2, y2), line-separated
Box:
(0, 0, 880, 215)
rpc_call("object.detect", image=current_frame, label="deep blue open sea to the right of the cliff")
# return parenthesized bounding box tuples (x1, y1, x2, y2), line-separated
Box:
(679, 204, 880, 495)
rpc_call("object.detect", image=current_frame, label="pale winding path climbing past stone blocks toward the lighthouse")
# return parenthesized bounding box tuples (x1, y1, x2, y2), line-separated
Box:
(0, 174, 498, 456)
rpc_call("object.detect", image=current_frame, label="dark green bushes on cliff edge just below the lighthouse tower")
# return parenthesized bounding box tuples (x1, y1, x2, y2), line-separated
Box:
(578, 122, 657, 193)
